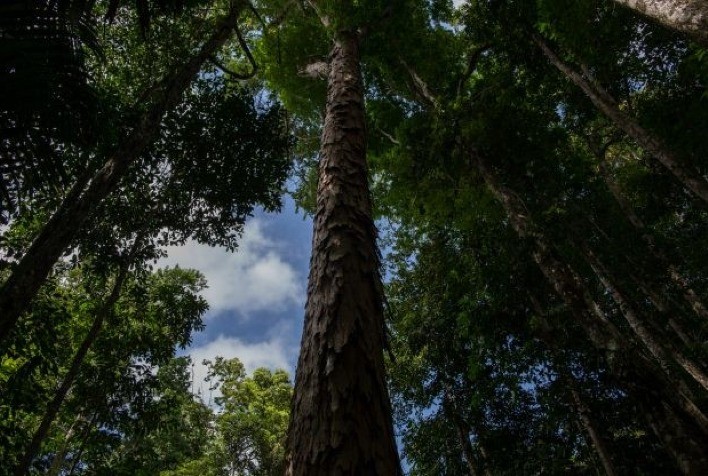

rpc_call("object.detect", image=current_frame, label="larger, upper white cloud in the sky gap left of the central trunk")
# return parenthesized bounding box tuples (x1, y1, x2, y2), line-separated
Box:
(160, 219, 304, 317)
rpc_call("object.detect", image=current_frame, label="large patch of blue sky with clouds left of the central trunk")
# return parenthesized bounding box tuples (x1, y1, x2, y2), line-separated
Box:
(161, 196, 312, 397)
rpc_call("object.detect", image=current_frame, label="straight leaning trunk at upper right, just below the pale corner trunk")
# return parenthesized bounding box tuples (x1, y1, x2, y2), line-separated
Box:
(533, 34, 708, 203)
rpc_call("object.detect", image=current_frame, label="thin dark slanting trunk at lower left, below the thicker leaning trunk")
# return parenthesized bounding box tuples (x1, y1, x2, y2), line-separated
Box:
(15, 245, 135, 476)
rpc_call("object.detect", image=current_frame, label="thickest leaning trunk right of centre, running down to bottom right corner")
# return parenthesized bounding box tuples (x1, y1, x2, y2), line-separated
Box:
(473, 151, 708, 475)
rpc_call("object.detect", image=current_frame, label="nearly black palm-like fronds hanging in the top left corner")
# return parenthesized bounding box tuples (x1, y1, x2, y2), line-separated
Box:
(0, 0, 98, 222)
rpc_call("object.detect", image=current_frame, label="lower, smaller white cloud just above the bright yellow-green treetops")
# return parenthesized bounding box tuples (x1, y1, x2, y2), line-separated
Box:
(189, 335, 295, 403)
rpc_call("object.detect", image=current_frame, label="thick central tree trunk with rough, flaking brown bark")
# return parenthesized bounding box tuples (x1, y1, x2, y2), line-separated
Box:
(286, 31, 401, 476)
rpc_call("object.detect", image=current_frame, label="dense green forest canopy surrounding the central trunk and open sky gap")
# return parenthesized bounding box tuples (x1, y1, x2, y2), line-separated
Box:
(0, 0, 708, 476)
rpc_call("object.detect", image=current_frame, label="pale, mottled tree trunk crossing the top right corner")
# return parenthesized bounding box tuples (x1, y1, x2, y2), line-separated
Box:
(615, 0, 708, 46)
